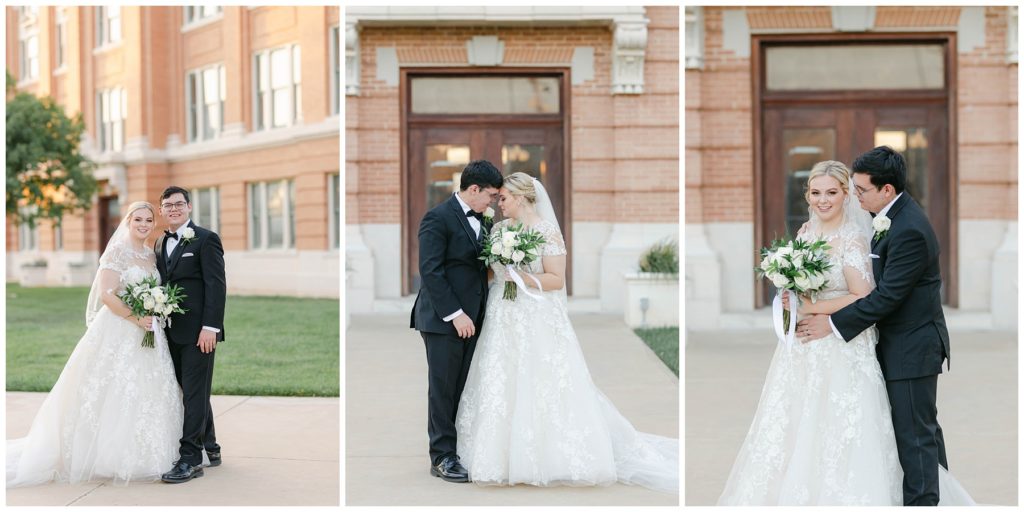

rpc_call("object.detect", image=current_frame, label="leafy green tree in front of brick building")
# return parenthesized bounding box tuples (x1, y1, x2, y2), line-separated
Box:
(7, 73, 96, 225)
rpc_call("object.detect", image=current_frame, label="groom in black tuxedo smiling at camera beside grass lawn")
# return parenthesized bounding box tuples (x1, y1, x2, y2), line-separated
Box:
(154, 186, 226, 483)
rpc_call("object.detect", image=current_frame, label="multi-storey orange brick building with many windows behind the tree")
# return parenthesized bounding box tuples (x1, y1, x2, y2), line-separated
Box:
(5, 6, 341, 297)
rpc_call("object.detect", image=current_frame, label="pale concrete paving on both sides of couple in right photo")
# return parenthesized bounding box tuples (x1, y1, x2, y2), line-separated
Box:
(685, 329, 1018, 506)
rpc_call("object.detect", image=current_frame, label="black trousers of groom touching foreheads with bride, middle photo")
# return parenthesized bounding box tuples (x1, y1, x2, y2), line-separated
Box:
(420, 328, 479, 465)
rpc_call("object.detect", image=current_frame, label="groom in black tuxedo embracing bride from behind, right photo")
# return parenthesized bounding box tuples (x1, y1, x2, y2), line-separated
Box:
(797, 146, 949, 506)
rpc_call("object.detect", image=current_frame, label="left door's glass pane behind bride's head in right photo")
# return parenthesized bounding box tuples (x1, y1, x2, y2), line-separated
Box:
(772, 128, 836, 239)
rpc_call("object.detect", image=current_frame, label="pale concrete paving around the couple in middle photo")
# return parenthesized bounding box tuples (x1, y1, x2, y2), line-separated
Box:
(345, 312, 679, 506)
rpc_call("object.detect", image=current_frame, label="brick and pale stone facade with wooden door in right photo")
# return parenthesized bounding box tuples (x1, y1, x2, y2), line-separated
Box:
(685, 6, 1018, 329)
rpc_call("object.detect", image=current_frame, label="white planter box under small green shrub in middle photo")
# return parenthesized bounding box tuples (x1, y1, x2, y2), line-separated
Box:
(625, 272, 679, 328)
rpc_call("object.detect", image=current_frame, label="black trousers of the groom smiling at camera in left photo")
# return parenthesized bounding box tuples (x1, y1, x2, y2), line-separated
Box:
(168, 342, 220, 466)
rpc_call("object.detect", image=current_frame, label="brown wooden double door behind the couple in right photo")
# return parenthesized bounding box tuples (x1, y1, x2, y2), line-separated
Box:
(759, 101, 955, 304)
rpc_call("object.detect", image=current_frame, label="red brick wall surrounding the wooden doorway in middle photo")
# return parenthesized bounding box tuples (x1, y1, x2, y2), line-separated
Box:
(345, 7, 679, 224)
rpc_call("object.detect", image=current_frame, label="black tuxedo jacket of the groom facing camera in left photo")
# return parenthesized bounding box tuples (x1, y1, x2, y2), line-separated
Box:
(154, 220, 227, 344)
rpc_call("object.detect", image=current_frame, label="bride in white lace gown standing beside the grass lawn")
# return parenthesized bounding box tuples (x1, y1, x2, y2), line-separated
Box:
(7, 202, 182, 487)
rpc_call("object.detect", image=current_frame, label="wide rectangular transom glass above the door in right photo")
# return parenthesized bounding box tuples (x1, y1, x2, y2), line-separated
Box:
(765, 44, 945, 91)
